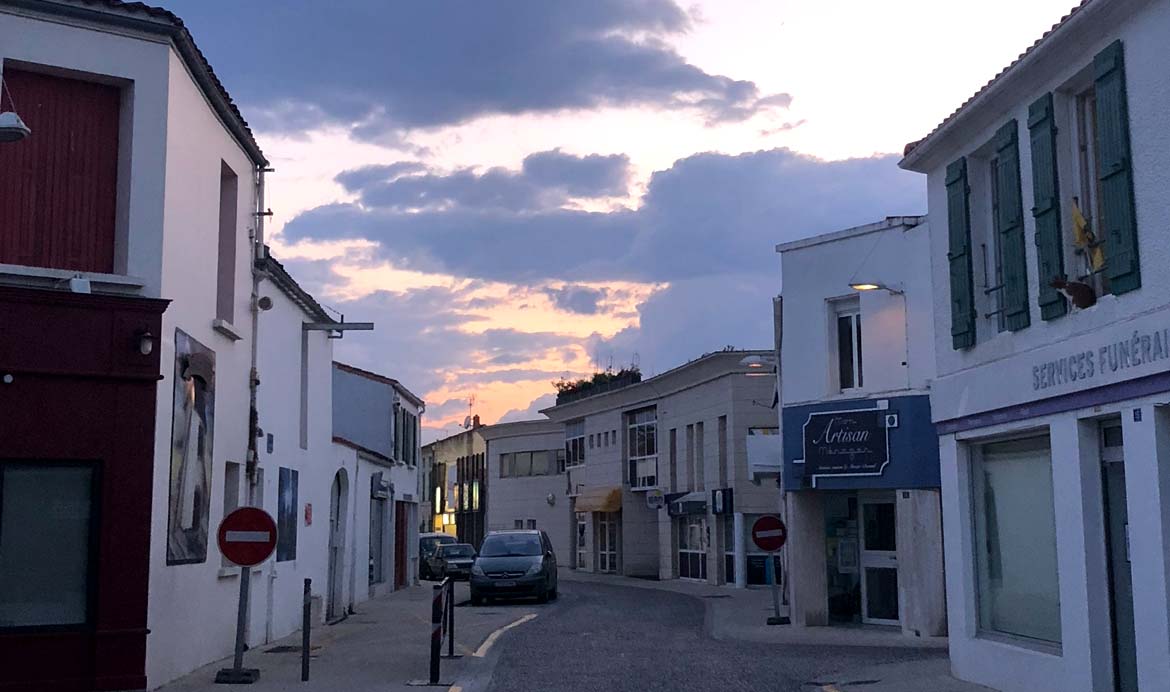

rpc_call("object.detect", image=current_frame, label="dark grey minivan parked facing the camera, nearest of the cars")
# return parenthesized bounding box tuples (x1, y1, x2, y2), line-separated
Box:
(470, 530, 557, 605)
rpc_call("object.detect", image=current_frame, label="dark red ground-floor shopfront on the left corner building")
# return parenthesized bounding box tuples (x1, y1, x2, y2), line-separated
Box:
(0, 287, 167, 692)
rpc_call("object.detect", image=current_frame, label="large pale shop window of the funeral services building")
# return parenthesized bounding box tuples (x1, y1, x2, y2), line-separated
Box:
(971, 437, 1060, 644)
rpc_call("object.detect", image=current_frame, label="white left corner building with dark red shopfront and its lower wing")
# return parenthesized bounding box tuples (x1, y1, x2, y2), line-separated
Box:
(0, 0, 372, 692)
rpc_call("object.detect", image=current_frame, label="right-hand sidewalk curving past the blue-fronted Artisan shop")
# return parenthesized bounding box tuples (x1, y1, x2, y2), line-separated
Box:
(560, 568, 989, 692)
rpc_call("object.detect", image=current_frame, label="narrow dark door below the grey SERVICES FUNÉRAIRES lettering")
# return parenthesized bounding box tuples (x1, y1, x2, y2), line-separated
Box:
(1101, 423, 1137, 692)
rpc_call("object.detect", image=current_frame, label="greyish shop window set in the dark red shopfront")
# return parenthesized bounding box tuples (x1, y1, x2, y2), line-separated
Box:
(0, 463, 97, 630)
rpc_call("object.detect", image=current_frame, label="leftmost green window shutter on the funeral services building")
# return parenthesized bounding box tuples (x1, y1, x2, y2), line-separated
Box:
(947, 158, 975, 349)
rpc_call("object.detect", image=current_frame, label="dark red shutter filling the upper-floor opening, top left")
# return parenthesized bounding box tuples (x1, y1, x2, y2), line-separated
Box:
(0, 63, 122, 273)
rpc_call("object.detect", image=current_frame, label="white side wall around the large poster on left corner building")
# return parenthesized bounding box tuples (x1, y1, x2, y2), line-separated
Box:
(146, 52, 263, 686)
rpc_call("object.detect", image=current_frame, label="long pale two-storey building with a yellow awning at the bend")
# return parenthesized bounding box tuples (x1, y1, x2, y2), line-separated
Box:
(540, 350, 779, 587)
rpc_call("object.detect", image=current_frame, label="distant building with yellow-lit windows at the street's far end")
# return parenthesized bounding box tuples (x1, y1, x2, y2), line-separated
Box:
(422, 416, 489, 548)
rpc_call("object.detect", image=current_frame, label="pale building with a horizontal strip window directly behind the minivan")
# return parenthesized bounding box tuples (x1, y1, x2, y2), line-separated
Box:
(479, 420, 574, 566)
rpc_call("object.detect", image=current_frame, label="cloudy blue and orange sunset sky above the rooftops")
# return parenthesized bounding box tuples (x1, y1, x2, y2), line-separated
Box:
(166, 0, 1073, 441)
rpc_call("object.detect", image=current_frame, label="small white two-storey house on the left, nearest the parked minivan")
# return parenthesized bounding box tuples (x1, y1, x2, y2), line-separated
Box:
(326, 363, 426, 616)
